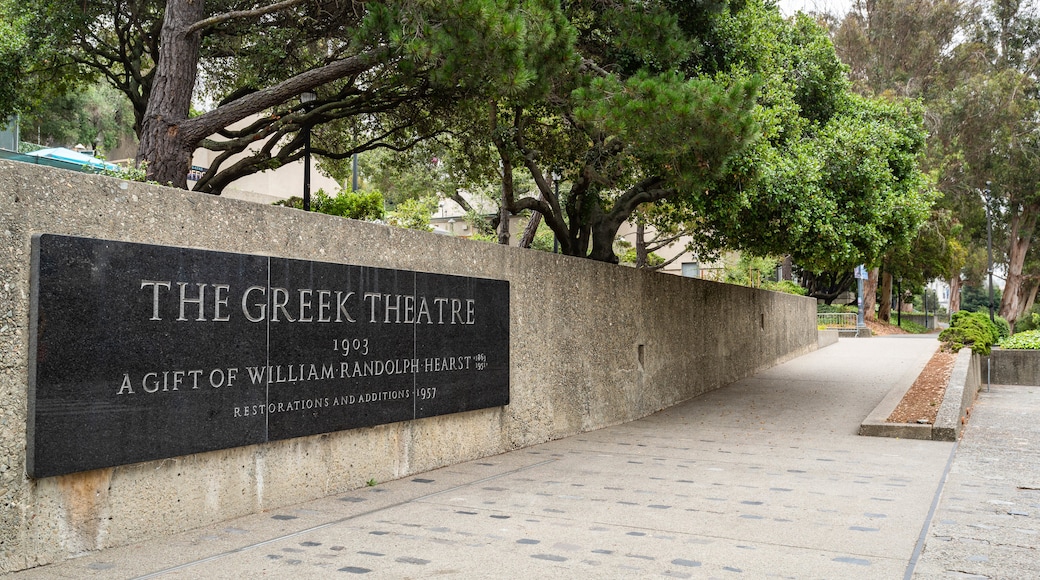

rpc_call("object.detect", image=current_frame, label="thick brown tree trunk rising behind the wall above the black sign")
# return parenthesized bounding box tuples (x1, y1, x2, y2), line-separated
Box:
(137, 0, 206, 189)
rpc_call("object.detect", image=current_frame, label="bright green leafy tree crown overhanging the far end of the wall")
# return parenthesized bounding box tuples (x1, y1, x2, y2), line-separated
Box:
(693, 10, 935, 272)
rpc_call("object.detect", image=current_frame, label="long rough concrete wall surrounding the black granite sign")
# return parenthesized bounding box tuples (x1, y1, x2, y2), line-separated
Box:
(0, 162, 817, 572)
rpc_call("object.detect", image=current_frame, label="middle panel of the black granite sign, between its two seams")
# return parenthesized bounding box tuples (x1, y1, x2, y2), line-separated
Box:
(268, 259, 416, 440)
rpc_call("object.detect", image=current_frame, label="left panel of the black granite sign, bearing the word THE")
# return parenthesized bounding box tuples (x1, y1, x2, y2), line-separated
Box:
(27, 235, 267, 477)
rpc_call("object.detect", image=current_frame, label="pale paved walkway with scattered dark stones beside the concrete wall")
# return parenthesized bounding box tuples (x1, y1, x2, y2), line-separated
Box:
(11, 337, 1040, 579)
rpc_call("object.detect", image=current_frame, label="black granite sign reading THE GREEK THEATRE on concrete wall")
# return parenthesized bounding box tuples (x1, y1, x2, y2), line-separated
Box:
(27, 234, 510, 477)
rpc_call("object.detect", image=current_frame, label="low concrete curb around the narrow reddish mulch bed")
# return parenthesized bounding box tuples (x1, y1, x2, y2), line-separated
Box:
(859, 348, 982, 441)
